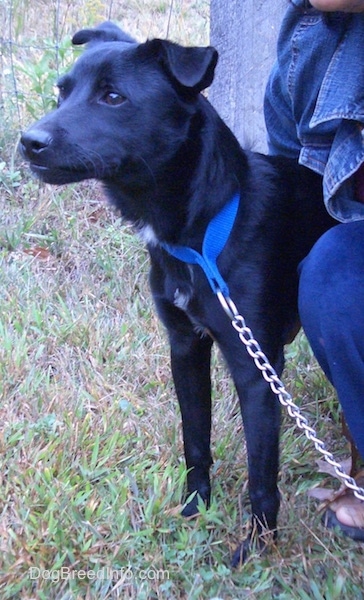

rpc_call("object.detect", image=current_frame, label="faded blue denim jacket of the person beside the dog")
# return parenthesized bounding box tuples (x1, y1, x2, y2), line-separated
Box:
(264, 0, 364, 221)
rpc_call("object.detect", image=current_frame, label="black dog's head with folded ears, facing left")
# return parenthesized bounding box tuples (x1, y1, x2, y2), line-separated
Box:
(20, 22, 217, 184)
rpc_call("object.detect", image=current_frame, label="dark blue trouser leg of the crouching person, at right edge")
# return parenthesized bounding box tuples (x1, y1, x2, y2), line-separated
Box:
(299, 221, 364, 458)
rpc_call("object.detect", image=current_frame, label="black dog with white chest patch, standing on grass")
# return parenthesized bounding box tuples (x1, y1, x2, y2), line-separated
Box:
(20, 23, 333, 564)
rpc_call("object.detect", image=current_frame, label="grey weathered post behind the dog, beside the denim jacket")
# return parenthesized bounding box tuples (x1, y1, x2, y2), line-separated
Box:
(209, 0, 287, 152)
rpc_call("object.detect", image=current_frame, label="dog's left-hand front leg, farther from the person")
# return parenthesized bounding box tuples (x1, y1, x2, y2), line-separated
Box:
(150, 258, 213, 517)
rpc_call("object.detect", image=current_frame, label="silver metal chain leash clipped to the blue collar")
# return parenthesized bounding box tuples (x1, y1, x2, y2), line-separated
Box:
(217, 290, 364, 500)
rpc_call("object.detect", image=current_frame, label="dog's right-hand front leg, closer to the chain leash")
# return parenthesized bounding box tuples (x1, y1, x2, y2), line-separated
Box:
(219, 333, 281, 566)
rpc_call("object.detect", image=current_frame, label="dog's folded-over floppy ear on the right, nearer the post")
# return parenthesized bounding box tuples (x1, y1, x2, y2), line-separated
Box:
(147, 39, 218, 93)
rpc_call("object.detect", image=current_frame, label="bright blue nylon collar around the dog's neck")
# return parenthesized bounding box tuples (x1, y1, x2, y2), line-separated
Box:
(161, 194, 240, 297)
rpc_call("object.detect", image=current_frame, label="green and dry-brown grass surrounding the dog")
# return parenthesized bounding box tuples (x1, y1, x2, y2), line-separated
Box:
(0, 0, 364, 600)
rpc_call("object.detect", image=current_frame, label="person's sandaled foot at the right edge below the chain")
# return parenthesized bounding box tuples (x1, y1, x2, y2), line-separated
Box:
(322, 470, 364, 542)
